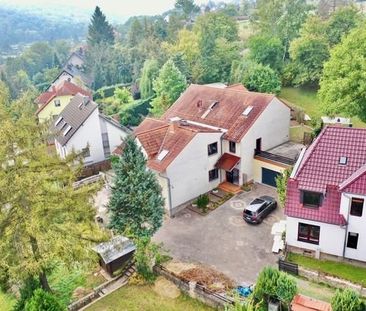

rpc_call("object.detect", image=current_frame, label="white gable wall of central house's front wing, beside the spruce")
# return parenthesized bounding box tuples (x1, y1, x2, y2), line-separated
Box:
(166, 133, 222, 208)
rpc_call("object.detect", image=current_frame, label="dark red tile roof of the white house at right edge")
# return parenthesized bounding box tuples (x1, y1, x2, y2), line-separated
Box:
(285, 126, 366, 225)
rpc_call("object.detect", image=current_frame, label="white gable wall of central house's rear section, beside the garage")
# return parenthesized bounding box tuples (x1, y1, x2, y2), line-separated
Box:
(240, 98, 290, 184)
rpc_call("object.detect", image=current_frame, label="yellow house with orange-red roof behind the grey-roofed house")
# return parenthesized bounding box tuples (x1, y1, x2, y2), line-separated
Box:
(36, 81, 92, 122)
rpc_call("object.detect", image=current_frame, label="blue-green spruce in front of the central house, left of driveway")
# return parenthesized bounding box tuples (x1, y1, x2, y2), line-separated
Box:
(108, 137, 164, 237)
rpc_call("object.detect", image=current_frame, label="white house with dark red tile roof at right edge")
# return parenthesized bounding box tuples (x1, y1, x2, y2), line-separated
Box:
(285, 127, 366, 261)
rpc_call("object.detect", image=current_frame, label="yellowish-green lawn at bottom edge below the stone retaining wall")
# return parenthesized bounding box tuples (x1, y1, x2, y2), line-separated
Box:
(86, 285, 213, 311)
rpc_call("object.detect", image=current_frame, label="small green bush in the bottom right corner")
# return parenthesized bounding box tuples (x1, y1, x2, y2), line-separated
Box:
(331, 288, 365, 311)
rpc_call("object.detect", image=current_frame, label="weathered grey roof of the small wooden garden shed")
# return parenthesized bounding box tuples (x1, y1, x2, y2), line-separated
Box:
(93, 235, 136, 264)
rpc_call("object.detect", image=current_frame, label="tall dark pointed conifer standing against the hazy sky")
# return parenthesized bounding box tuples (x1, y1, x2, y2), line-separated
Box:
(88, 6, 114, 46)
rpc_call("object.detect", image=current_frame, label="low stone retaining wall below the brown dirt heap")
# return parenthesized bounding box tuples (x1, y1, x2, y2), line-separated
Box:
(154, 265, 234, 309)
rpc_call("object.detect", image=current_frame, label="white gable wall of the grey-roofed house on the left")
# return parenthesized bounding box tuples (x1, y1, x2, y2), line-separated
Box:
(65, 109, 105, 164)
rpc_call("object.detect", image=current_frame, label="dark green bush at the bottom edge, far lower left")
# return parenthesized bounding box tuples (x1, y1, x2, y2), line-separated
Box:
(24, 288, 66, 311)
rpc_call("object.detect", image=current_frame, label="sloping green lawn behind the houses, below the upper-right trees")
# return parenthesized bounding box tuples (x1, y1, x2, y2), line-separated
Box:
(279, 87, 366, 127)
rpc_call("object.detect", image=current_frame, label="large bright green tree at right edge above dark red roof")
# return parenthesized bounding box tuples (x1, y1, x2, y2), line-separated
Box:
(319, 25, 366, 121)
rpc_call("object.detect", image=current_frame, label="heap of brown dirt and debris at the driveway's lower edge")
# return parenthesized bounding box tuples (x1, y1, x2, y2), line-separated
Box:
(179, 266, 235, 292)
